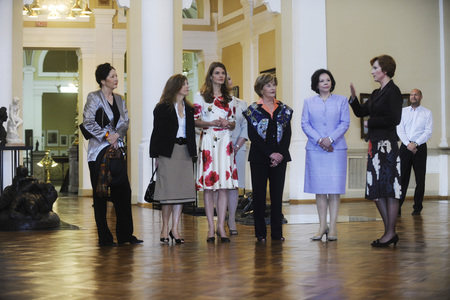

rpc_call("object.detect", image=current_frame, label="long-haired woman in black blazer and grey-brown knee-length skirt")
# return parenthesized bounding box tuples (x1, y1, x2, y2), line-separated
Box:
(150, 74, 197, 244)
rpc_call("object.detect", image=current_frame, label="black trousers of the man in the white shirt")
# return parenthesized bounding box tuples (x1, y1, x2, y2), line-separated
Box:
(400, 143, 427, 211)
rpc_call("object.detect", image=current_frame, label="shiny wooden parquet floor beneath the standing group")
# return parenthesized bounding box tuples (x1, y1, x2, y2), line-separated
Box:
(0, 196, 450, 299)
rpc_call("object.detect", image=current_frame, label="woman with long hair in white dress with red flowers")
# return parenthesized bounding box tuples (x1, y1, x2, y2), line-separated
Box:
(194, 62, 238, 242)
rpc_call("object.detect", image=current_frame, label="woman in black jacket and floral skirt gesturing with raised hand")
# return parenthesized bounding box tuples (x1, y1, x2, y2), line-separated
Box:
(349, 55, 403, 247)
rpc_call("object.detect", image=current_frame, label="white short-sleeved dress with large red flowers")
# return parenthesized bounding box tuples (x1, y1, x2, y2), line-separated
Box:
(194, 93, 238, 190)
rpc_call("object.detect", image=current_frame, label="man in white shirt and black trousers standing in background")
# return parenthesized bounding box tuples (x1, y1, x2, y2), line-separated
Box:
(397, 89, 433, 216)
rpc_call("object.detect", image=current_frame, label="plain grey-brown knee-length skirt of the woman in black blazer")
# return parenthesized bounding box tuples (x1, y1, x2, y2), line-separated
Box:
(154, 144, 196, 204)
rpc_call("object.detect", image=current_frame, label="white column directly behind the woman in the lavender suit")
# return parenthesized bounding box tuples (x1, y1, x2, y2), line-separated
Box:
(281, 0, 327, 199)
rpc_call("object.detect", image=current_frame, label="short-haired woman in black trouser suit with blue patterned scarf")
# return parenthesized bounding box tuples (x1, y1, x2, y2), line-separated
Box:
(244, 74, 293, 242)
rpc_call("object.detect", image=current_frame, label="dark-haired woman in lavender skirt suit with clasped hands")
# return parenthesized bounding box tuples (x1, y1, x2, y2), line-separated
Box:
(302, 69, 350, 241)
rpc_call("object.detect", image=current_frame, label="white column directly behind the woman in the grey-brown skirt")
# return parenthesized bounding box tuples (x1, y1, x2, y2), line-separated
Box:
(136, 1, 175, 202)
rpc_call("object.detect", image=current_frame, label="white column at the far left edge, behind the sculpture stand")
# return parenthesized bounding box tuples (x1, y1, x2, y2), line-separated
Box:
(0, 0, 13, 188)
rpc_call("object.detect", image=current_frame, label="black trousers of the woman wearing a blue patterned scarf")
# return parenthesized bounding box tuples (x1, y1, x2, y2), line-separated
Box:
(250, 162, 287, 239)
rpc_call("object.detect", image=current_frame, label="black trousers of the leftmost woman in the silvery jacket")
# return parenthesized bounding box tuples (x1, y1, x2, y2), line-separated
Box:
(89, 151, 133, 244)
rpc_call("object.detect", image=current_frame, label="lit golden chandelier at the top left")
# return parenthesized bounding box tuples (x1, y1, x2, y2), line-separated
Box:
(23, 0, 92, 20)
